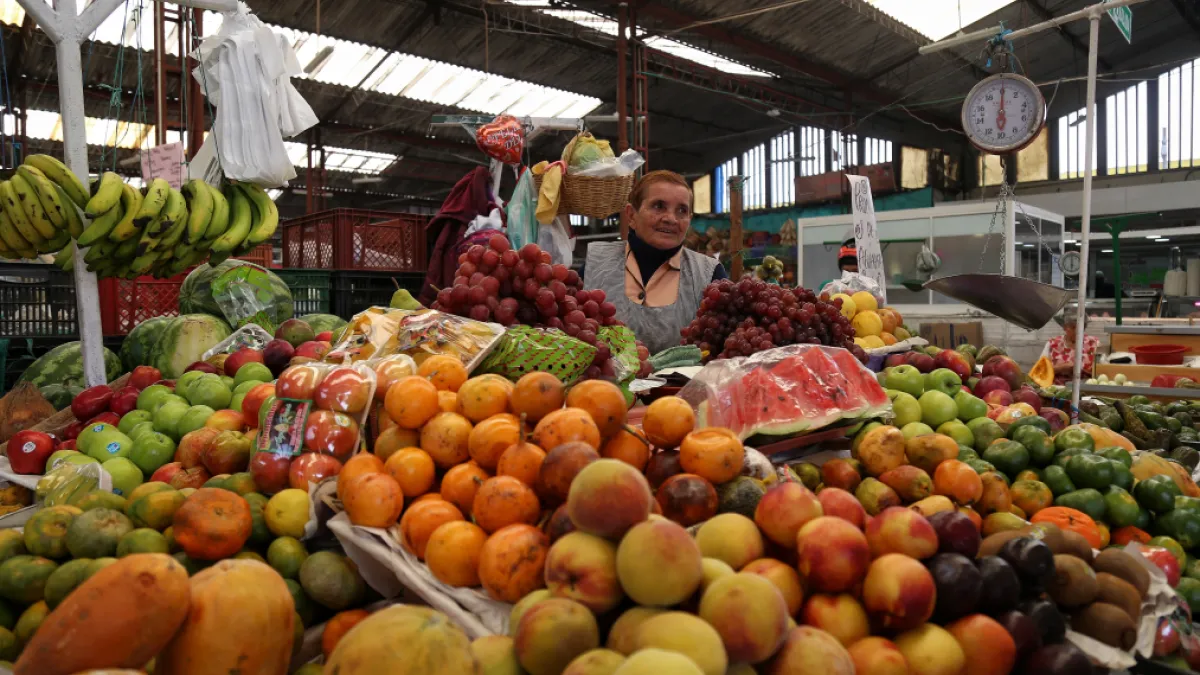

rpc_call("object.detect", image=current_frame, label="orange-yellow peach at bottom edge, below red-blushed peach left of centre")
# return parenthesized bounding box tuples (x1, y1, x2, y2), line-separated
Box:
(514, 598, 600, 675)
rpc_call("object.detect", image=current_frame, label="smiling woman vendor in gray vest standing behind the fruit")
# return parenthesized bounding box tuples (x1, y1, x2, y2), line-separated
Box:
(581, 171, 728, 353)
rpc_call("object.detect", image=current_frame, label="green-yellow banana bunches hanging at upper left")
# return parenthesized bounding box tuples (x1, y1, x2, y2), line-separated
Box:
(0, 155, 280, 279)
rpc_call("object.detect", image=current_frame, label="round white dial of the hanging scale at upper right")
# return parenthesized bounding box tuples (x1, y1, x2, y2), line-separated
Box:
(962, 73, 1046, 155)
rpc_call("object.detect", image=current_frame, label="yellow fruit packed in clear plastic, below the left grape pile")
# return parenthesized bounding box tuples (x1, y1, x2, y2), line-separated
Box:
(325, 307, 504, 371)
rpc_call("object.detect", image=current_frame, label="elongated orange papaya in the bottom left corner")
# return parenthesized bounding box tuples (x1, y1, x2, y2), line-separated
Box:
(13, 554, 191, 675)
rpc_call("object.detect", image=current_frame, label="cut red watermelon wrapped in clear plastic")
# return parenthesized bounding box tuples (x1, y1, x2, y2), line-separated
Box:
(679, 345, 892, 440)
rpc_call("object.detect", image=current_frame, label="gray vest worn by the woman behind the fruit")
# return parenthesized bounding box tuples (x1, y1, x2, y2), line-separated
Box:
(584, 241, 718, 354)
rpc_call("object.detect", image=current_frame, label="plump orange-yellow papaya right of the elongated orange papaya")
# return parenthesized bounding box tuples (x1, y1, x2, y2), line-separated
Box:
(155, 557, 296, 675)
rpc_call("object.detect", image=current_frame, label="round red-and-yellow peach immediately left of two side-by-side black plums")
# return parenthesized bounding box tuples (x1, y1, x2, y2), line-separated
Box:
(863, 554, 937, 631)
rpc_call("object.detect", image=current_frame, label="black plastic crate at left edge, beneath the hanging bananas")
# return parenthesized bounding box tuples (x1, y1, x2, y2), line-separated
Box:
(0, 263, 79, 338)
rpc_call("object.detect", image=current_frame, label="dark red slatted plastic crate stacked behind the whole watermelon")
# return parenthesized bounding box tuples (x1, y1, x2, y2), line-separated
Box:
(283, 209, 428, 271)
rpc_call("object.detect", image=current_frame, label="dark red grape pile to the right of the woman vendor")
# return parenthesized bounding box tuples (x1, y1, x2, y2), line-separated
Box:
(680, 279, 866, 363)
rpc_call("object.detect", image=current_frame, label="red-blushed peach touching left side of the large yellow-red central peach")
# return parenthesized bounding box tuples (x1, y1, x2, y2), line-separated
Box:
(546, 532, 625, 614)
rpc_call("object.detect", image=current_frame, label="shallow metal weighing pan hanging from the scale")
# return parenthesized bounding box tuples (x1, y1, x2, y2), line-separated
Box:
(924, 274, 1074, 330)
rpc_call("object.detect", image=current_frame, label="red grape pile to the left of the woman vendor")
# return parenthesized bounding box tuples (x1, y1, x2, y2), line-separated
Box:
(433, 234, 650, 378)
